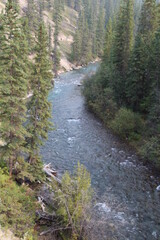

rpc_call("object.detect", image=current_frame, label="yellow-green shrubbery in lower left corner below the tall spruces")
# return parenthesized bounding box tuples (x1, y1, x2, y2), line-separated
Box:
(0, 169, 36, 237)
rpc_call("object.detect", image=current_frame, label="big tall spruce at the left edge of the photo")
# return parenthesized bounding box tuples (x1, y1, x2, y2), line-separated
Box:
(0, 0, 28, 176)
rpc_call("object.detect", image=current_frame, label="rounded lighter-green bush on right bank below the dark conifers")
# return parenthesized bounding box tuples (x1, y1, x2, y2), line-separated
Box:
(110, 108, 144, 140)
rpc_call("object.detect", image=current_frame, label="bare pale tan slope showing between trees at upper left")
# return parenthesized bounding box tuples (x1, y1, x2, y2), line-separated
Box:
(0, 0, 78, 72)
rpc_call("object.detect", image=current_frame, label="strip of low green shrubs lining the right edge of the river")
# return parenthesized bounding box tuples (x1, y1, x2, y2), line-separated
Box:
(83, 73, 160, 171)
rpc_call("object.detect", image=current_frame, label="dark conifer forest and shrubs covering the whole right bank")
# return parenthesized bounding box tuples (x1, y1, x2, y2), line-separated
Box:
(84, 0, 160, 167)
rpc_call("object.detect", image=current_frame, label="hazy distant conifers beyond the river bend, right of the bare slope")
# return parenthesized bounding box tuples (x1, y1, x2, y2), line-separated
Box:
(71, 0, 106, 65)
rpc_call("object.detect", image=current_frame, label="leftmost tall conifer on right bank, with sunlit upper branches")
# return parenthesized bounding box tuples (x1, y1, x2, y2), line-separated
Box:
(113, 0, 134, 105)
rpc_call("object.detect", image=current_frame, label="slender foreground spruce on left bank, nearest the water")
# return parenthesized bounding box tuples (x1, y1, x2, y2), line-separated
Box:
(27, 23, 53, 176)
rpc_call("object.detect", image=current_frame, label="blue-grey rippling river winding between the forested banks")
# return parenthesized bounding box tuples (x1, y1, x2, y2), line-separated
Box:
(41, 64, 160, 240)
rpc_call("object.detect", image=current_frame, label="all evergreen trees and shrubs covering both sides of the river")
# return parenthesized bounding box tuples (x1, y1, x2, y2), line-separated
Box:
(0, 0, 160, 240)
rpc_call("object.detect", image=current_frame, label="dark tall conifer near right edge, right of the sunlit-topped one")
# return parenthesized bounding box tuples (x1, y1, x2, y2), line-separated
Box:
(126, 0, 156, 113)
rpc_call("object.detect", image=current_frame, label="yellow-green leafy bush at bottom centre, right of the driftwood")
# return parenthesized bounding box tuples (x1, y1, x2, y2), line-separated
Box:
(53, 163, 92, 240)
